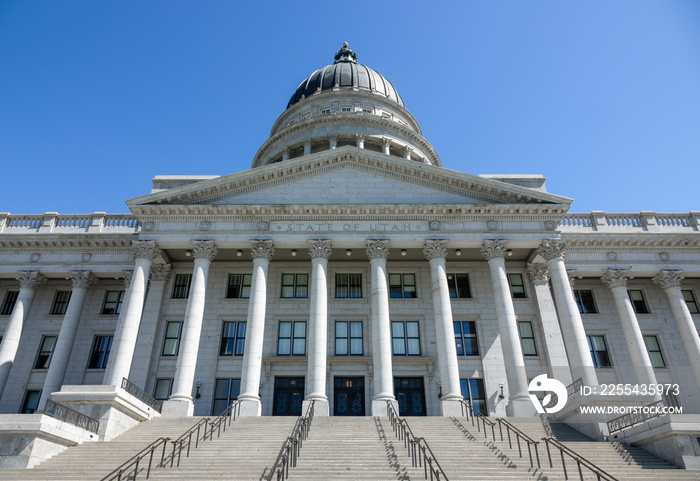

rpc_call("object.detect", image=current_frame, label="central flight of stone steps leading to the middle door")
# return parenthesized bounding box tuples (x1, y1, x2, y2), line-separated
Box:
(289, 417, 424, 481)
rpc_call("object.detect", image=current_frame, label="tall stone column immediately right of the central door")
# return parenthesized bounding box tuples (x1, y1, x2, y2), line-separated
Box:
(366, 239, 398, 416)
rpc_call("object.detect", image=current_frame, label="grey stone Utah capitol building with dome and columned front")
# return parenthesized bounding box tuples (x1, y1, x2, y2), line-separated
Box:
(0, 44, 700, 467)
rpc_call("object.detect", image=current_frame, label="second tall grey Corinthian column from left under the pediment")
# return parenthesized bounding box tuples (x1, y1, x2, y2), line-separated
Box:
(163, 241, 218, 417)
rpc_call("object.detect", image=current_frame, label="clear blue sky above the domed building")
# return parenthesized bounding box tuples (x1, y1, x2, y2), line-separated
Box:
(0, 0, 700, 214)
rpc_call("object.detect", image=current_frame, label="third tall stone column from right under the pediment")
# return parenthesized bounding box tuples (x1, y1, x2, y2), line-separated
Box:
(423, 240, 463, 416)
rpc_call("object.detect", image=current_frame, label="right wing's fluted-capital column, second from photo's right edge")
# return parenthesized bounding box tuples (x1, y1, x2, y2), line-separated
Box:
(600, 269, 656, 384)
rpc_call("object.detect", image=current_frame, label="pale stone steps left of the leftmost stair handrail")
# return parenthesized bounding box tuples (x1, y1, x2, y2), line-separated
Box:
(0, 417, 202, 481)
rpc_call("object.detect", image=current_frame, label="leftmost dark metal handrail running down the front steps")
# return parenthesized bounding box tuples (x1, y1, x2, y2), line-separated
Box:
(100, 401, 240, 481)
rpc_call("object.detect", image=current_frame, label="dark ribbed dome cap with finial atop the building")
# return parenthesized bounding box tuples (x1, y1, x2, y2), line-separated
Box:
(287, 42, 404, 108)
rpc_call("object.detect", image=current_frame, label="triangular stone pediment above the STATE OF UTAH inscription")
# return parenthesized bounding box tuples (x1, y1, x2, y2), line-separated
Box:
(127, 146, 571, 214)
